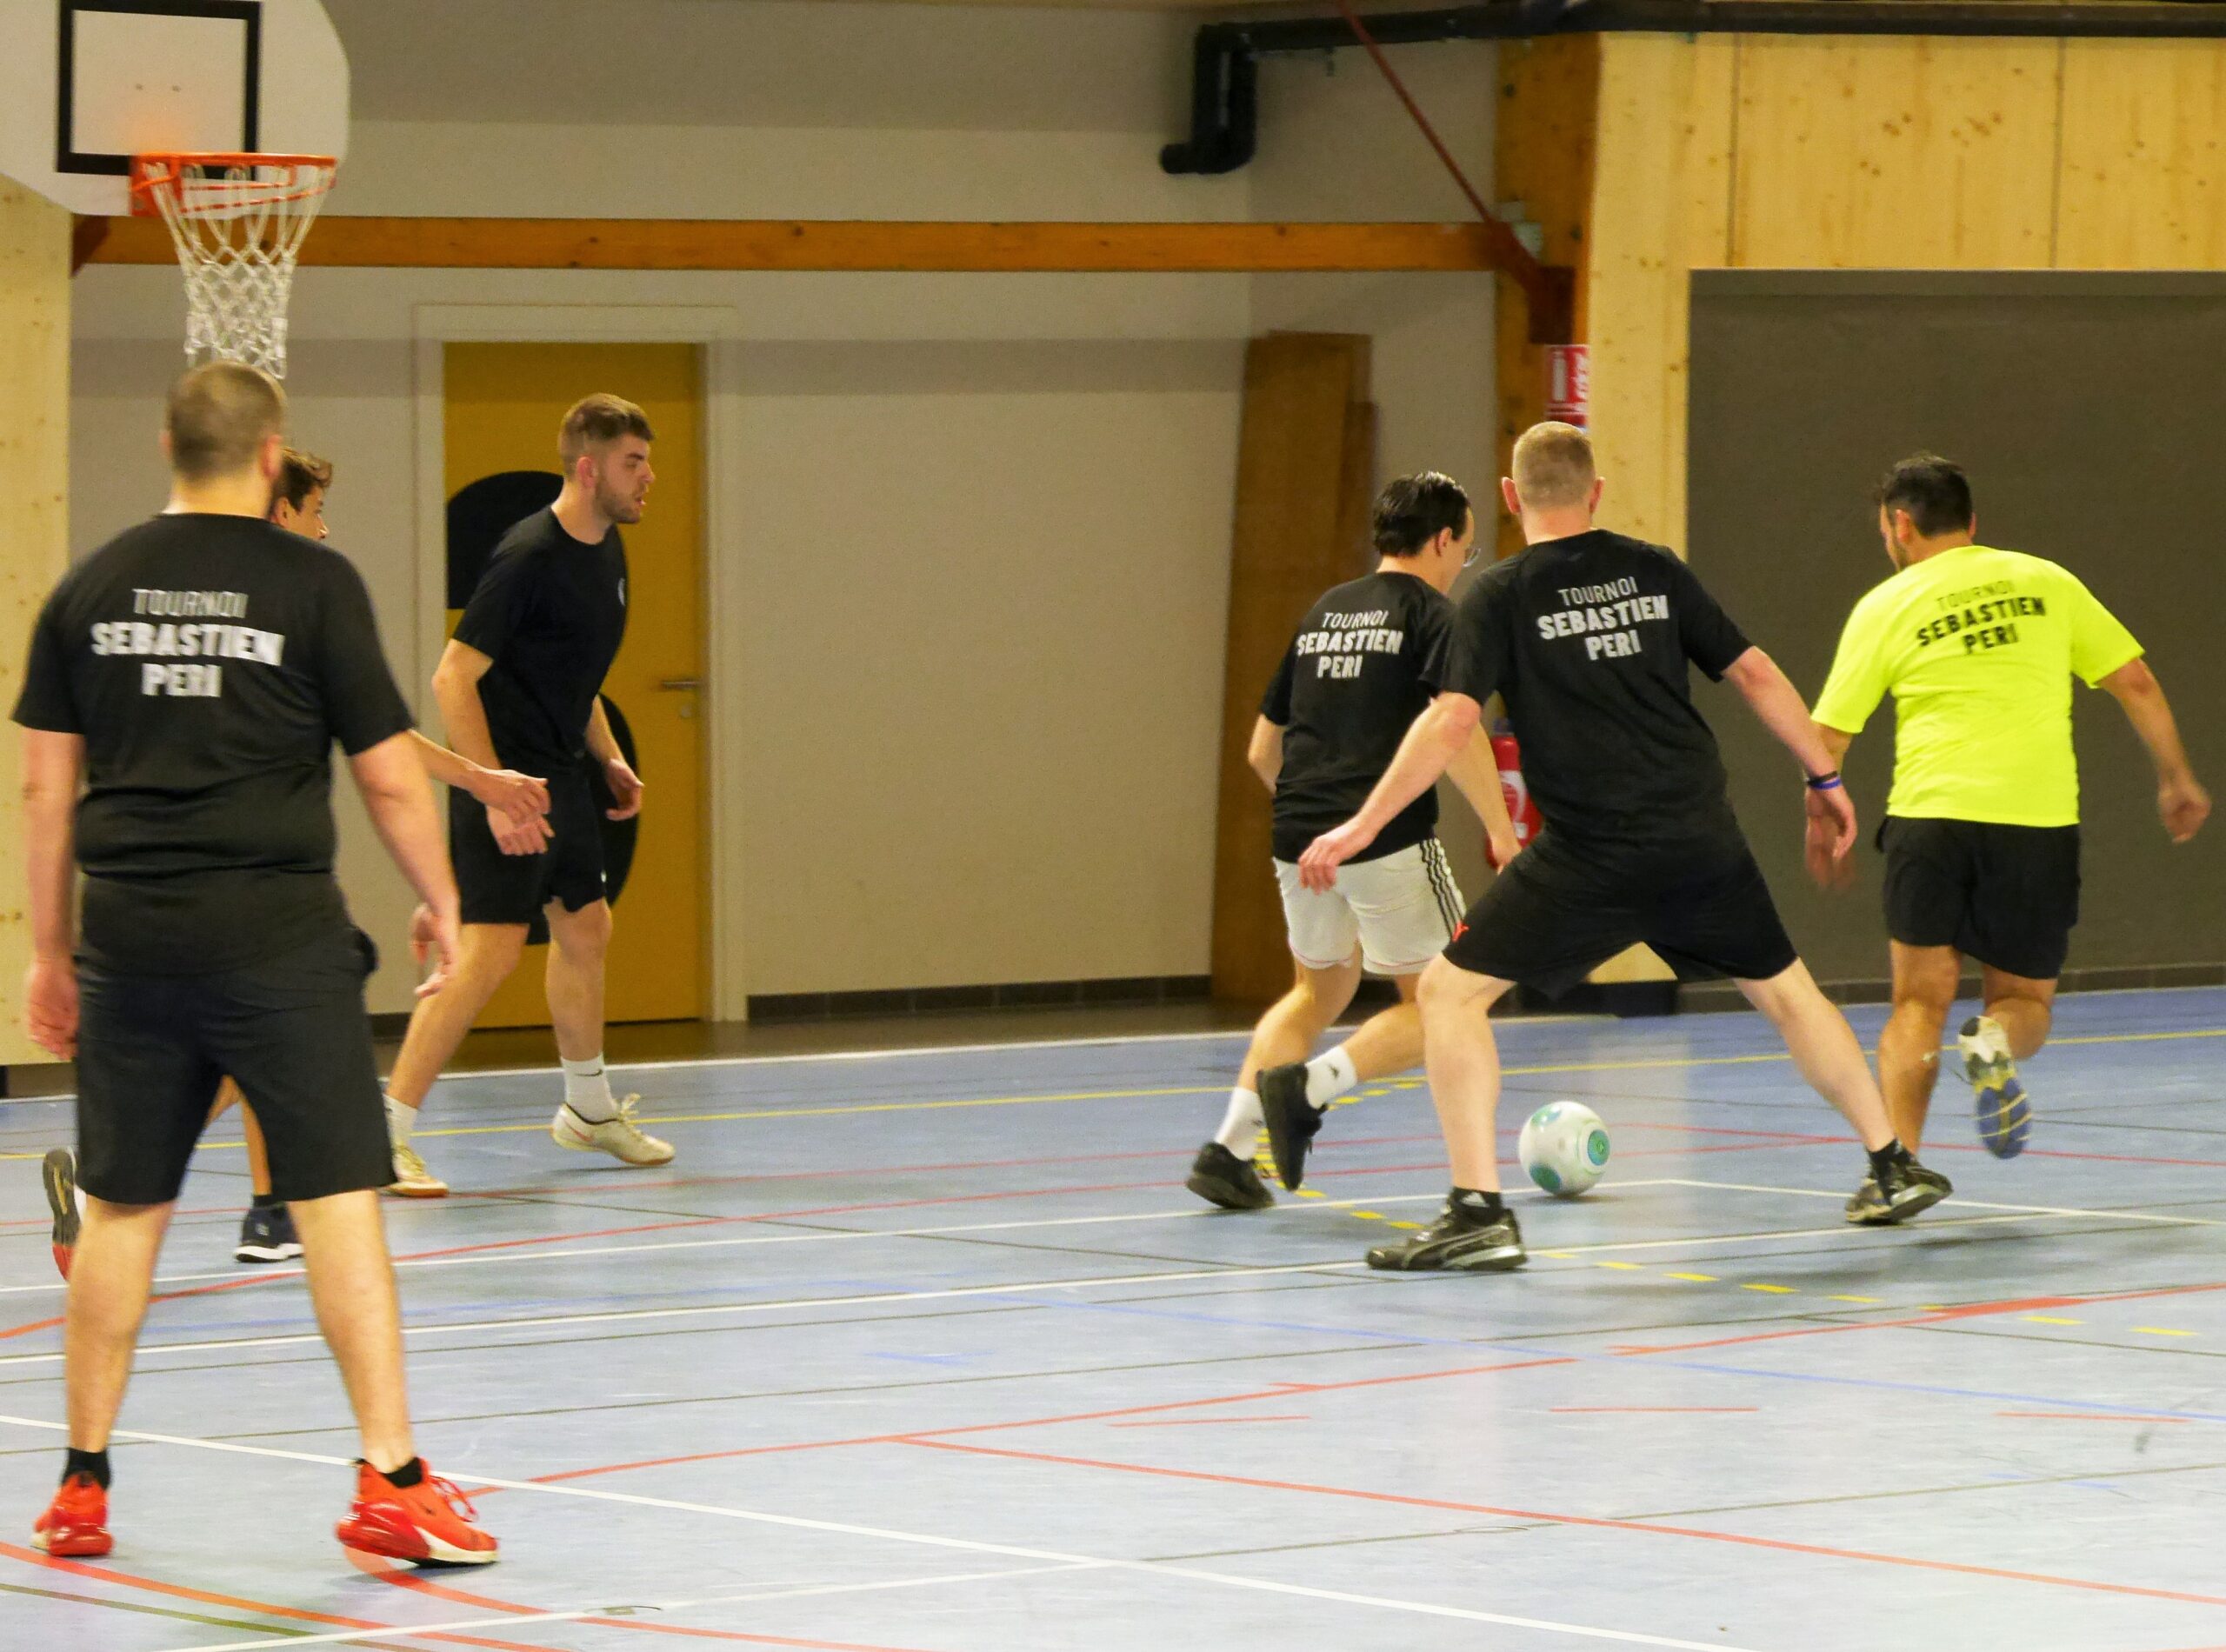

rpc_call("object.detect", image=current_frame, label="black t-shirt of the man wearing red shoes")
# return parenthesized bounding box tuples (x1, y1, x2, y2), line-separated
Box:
(16, 515, 410, 976)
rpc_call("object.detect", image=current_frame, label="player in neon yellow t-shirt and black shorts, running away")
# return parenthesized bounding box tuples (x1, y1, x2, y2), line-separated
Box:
(1809, 454, 2210, 1158)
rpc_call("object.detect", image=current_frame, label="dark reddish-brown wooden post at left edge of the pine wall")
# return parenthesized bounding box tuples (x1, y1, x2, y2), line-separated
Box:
(1496, 33, 1603, 556)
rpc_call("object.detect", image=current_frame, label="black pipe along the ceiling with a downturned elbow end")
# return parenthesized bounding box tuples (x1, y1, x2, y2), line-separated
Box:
(1160, 0, 2226, 174)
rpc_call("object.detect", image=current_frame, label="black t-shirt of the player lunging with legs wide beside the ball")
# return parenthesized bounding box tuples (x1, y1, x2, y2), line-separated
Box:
(1427, 528, 1748, 842)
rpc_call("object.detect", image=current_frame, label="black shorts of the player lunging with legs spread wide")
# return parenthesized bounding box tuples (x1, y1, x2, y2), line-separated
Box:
(1444, 830, 1798, 997)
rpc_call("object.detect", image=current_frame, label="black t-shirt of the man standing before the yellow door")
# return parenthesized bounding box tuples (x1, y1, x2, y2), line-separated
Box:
(457, 510, 625, 775)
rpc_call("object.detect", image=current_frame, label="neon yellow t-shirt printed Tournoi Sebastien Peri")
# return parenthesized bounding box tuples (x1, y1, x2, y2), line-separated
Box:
(1816, 545, 2142, 826)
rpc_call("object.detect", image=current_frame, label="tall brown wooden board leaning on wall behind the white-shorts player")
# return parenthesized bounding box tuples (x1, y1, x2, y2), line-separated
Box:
(1213, 334, 1376, 1004)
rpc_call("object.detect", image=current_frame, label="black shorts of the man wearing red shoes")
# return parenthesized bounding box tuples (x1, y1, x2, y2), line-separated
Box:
(78, 929, 394, 1204)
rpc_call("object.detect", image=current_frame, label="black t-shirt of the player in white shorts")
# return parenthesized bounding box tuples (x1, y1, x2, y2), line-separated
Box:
(1260, 575, 1454, 859)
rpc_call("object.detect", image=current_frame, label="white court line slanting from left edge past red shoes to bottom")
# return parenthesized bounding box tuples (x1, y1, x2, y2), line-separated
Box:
(0, 1416, 1754, 1652)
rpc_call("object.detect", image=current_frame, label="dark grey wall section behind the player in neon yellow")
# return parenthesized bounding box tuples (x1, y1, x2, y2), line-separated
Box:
(1689, 271, 2226, 982)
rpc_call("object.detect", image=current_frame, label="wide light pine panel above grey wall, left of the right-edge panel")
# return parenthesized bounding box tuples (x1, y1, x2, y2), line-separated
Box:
(1732, 36, 2063, 270)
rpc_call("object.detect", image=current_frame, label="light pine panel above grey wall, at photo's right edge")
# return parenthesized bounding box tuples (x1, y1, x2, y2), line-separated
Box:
(2056, 40, 2226, 270)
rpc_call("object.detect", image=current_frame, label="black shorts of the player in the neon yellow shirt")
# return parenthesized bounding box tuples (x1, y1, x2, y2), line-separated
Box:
(1879, 815, 2079, 982)
